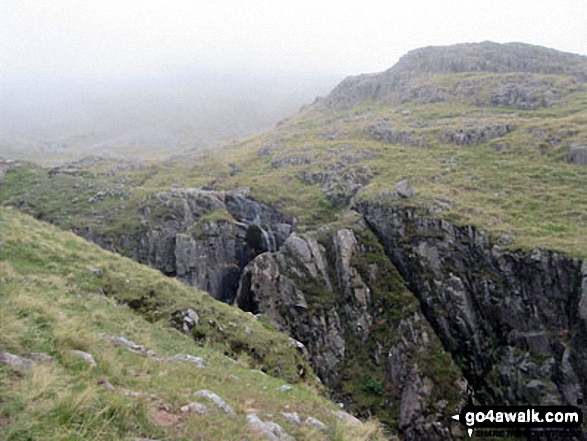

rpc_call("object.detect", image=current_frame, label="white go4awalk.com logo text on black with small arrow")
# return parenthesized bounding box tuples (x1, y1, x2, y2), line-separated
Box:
(452, 405, 583, 437)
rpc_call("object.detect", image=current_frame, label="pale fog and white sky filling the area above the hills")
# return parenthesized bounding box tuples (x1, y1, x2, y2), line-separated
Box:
(0, 0, 587, 161)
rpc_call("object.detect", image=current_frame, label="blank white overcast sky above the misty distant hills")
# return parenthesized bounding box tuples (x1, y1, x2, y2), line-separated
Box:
(0, 0, 587, 81)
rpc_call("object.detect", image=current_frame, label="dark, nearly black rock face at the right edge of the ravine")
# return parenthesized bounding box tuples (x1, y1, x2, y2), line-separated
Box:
(356, 203, 587, 405)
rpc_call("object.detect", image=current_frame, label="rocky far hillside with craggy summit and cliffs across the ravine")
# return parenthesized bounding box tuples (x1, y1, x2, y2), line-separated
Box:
(0, 43, 587, 440)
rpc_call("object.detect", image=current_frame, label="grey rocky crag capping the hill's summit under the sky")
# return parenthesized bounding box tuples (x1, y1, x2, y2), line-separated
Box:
(322, 42, 587, 110)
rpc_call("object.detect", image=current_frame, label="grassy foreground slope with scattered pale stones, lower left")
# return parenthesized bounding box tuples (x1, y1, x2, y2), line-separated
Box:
(0, 209, 381, 440)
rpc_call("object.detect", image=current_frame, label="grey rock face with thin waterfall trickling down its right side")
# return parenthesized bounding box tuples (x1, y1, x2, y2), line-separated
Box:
(78, 189, 291, 303)
